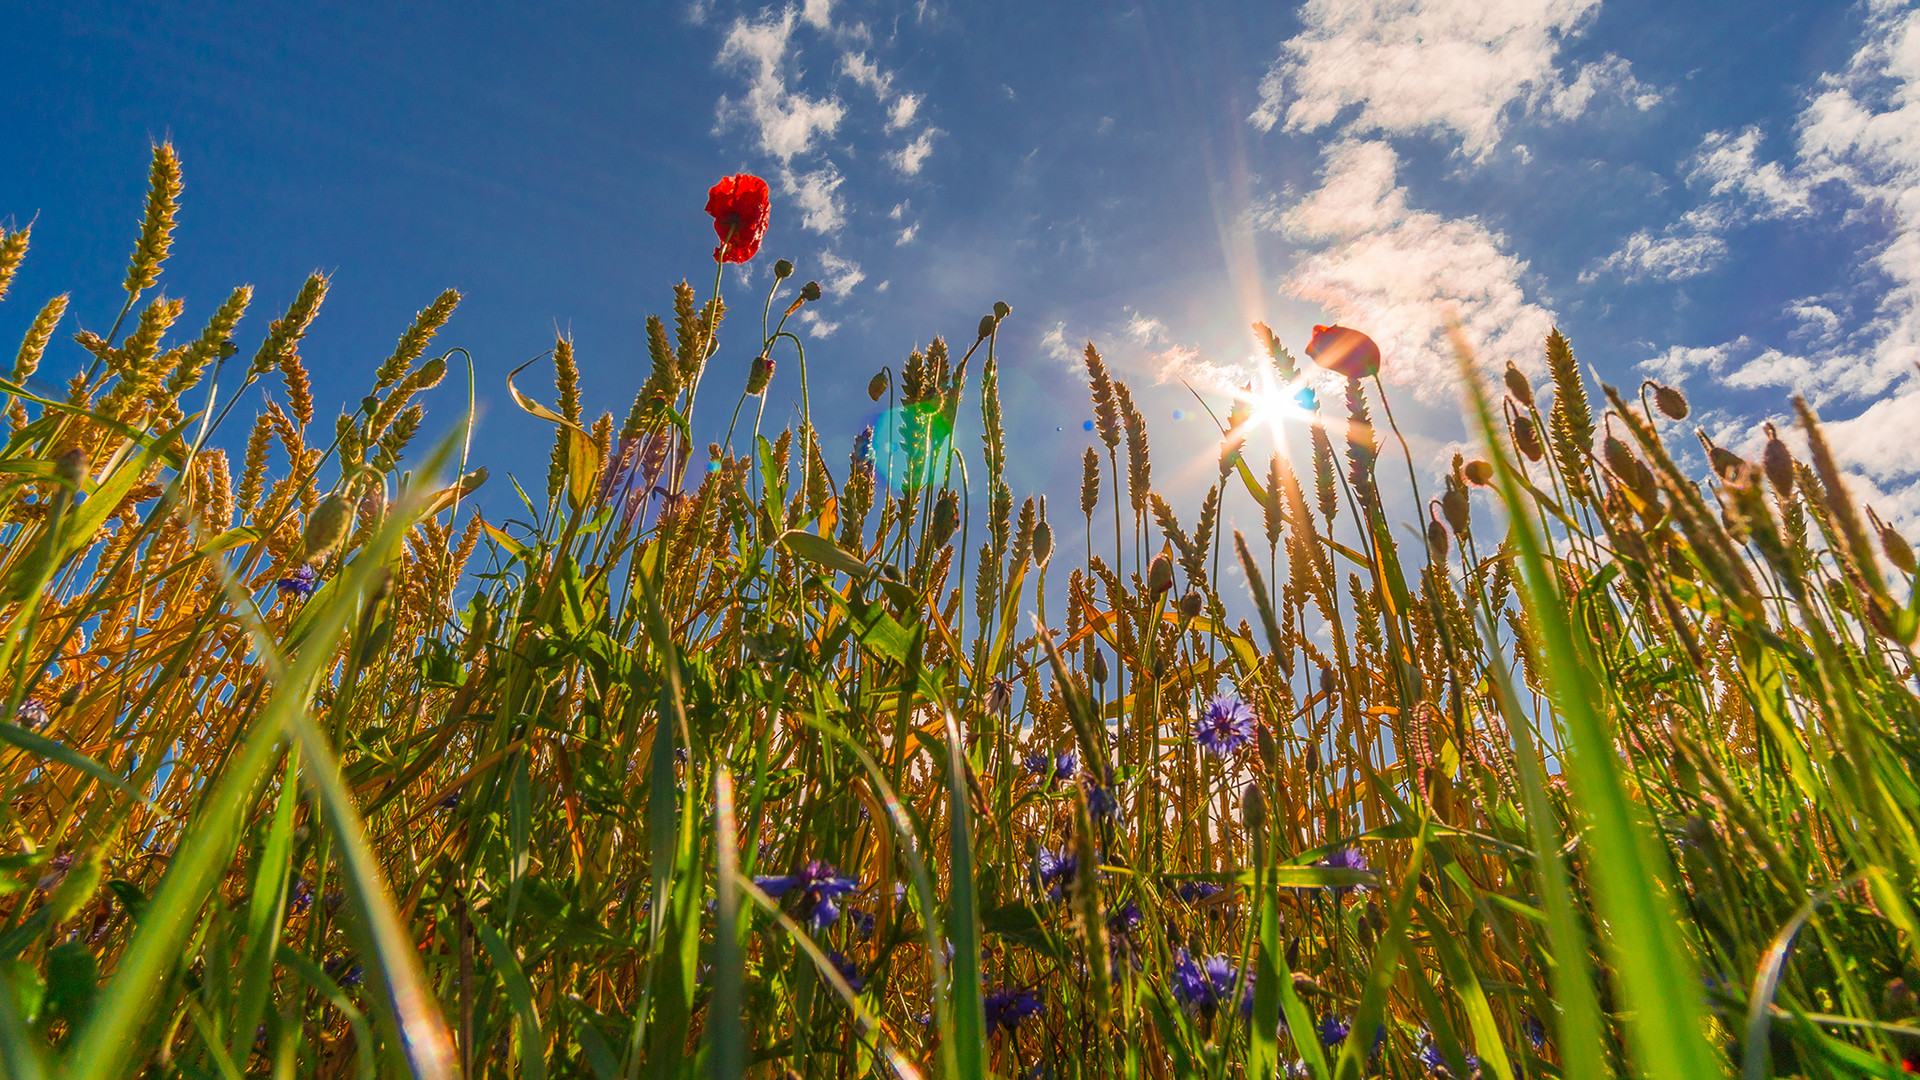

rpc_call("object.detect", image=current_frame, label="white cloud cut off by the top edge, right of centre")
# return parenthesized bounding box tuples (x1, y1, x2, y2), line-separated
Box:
(1250, 0, 1659, 158)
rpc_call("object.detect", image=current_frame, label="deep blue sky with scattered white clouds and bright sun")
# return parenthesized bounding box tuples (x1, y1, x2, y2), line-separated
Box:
(0, 0, 1920, 538)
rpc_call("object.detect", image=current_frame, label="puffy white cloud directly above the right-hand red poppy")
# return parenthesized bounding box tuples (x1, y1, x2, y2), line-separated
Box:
(1281, 140, 1553, 390)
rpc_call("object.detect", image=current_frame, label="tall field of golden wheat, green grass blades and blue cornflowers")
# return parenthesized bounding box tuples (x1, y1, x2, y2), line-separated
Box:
(0, 148, 1920, 1080)
